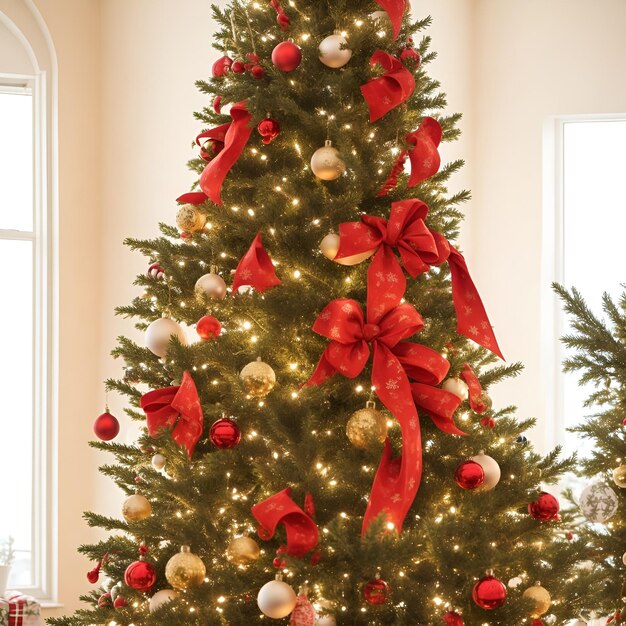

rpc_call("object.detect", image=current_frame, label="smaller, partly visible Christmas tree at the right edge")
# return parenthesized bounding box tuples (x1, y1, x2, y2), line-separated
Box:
(555, 285, 626, 623)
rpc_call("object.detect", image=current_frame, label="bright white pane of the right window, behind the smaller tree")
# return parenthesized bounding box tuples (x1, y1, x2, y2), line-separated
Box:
(563, 120, 626, 453)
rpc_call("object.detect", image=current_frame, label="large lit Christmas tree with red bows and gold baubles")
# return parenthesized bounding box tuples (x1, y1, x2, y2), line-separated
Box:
(50, 0, 584, 626)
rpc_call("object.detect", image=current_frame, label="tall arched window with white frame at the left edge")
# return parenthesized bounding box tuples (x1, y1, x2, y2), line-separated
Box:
(0, 0, 57, 599)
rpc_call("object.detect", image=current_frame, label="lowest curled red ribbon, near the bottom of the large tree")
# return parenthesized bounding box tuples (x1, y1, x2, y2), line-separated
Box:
(252, 488, 319, 557)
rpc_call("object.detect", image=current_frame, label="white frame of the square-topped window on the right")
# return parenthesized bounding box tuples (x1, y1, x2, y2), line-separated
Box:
(541, 113, 626, 447)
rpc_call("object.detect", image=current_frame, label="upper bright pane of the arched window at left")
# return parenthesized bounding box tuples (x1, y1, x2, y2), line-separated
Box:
(0, 94, 33, 231)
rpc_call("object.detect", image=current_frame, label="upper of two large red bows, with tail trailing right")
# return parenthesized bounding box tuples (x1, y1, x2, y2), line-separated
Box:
(335, 200, 503, 358)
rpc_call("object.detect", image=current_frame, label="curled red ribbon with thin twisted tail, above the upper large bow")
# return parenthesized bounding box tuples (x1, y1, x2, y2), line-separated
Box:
(377, 117, 443, 197)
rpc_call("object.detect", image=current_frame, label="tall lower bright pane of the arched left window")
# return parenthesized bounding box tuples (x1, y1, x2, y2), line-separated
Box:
(0, 239, 34, 588)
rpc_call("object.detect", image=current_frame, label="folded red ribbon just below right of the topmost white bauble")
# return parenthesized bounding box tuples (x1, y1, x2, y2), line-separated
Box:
(361, 50, 415, 122)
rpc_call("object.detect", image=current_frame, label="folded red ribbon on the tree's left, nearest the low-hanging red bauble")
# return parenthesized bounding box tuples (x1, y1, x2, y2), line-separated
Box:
(140, 372, 204, 458)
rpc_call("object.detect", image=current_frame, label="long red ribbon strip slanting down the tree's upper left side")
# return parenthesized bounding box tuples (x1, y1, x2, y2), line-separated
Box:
(200, 102, 252, 204)
